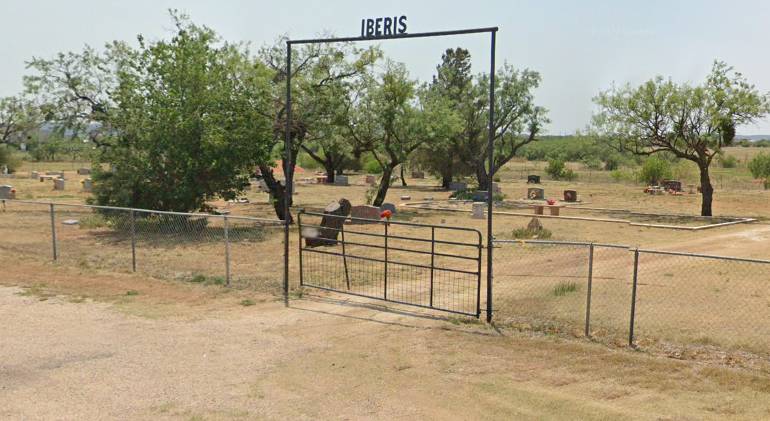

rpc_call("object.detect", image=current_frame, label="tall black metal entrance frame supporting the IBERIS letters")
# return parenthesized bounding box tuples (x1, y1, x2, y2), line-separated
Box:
(283, 26, 498, 322)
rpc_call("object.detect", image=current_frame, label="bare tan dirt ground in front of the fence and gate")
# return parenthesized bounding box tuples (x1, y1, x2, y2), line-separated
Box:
(0, 260, 770, 420)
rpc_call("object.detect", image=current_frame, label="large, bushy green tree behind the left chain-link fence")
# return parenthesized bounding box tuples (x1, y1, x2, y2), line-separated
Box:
(27, 14, 272, 212)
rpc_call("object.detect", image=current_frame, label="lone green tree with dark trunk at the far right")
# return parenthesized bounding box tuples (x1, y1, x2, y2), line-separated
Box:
(593, 61, 770, 216)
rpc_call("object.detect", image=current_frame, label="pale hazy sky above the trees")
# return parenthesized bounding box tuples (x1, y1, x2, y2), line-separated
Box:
(0, 0, 770, 135)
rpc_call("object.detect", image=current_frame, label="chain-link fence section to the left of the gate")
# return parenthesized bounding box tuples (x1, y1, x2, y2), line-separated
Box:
(0, 200, 284, 293)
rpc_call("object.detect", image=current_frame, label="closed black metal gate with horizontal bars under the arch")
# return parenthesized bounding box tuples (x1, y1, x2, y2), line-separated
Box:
(297, 211, 482, 317)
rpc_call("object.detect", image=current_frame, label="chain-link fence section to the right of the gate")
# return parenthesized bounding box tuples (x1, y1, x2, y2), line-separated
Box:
(493, 240, 770, 354)
